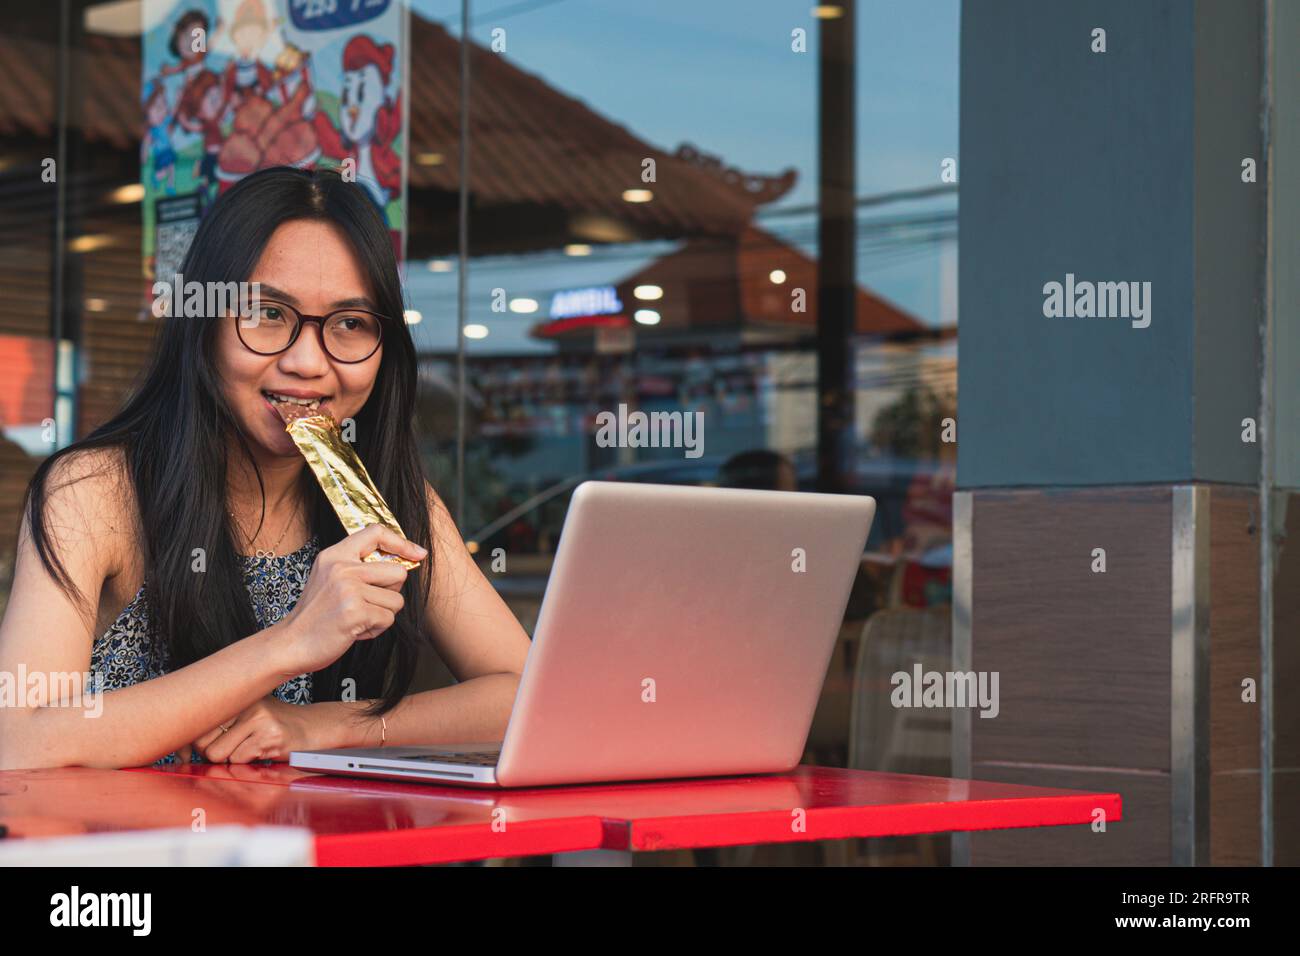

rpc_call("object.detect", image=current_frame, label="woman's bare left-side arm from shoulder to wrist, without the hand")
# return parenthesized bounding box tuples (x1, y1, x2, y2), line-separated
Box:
(0, 453, 301, 770)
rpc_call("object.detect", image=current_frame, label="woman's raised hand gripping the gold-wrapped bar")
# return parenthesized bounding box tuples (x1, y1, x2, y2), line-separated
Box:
(277, 524, 428, 680)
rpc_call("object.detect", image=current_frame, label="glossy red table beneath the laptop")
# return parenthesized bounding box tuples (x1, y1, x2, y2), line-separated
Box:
(0, 763, 1121, 866)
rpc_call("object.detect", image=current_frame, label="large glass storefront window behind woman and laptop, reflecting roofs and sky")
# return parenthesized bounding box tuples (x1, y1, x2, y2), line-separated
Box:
(0, 0, 958, 780)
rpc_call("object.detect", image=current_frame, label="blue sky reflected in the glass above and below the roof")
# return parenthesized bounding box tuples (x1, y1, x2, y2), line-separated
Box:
(408, 0, 959, 352)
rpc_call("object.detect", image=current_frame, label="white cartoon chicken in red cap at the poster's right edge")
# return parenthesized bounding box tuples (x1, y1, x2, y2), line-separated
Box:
(312, 34, 402, 212)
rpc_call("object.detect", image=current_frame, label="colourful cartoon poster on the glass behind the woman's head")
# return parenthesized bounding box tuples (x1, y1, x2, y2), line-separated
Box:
(140, 0, 408, 291)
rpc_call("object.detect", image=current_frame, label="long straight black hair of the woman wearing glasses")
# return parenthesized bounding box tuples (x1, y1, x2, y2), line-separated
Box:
(23, 166, 434, 715)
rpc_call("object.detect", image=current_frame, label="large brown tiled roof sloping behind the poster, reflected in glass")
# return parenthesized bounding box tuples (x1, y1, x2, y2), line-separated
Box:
(0, 14, 796, 247)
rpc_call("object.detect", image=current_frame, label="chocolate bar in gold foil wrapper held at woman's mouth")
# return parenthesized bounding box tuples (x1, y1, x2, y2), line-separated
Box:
(276, 405, 420, 571)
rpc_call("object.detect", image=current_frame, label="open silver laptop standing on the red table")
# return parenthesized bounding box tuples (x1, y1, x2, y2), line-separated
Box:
(289, 481, 876, 787)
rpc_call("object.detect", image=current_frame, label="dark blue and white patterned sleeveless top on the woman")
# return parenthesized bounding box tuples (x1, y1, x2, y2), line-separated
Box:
(90, 535, 320, 766)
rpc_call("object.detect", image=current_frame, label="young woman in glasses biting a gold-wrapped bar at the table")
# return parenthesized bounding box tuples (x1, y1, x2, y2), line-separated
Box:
(0, 166, 529, 769)
